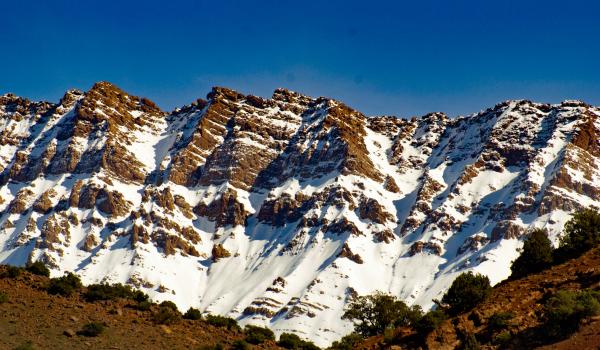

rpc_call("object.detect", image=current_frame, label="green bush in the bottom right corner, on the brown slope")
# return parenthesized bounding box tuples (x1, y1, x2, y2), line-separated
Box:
(544, 290, 600, 338)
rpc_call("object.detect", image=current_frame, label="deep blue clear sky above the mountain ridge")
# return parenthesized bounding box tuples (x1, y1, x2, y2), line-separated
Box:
(0, 0, 600, 116)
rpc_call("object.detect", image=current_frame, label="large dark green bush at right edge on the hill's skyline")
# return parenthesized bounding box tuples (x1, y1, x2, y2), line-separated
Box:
(555, 209, 600, 261)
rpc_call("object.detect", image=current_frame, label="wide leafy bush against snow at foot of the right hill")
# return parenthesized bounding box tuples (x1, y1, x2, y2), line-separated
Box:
(342, 292, 422, 337)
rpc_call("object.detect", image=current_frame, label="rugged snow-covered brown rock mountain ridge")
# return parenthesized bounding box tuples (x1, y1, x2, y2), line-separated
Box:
(0, 82, 600, 345)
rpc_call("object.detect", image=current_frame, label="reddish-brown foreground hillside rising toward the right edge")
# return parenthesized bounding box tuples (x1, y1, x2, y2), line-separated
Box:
(356, 248, 600, 350)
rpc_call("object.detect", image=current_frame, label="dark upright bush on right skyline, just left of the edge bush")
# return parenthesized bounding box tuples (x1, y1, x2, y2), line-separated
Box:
(510, 229, 554, 278)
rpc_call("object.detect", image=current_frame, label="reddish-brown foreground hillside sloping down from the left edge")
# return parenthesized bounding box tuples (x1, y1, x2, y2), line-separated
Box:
(0, 266, 279, 350)
